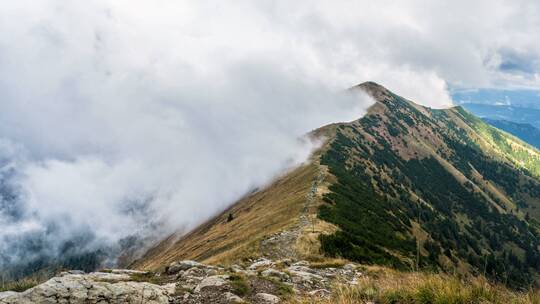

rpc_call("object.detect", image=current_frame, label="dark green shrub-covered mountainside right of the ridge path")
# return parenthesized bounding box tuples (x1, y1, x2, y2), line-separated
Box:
(320, 84, 540, 287)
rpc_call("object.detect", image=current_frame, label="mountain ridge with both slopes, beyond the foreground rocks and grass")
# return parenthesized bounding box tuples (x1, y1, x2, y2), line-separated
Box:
(133, 83, 540, 286)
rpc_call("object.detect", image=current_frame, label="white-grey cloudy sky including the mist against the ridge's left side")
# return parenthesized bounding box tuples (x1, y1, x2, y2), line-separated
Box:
(0, 0, 540, 266)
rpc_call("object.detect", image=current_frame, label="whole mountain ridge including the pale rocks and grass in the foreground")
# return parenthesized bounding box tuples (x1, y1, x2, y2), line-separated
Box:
(0, 82, 540, 304)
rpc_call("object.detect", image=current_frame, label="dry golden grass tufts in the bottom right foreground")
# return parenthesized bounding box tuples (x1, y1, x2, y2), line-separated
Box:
(287, 267, 540, 304)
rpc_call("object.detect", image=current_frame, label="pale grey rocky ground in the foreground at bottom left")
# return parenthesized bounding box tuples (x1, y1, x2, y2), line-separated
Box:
(0, 259, 363, 304)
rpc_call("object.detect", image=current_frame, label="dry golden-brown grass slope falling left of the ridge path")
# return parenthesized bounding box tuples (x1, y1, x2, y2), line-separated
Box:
(131, 162, 318, 271)
